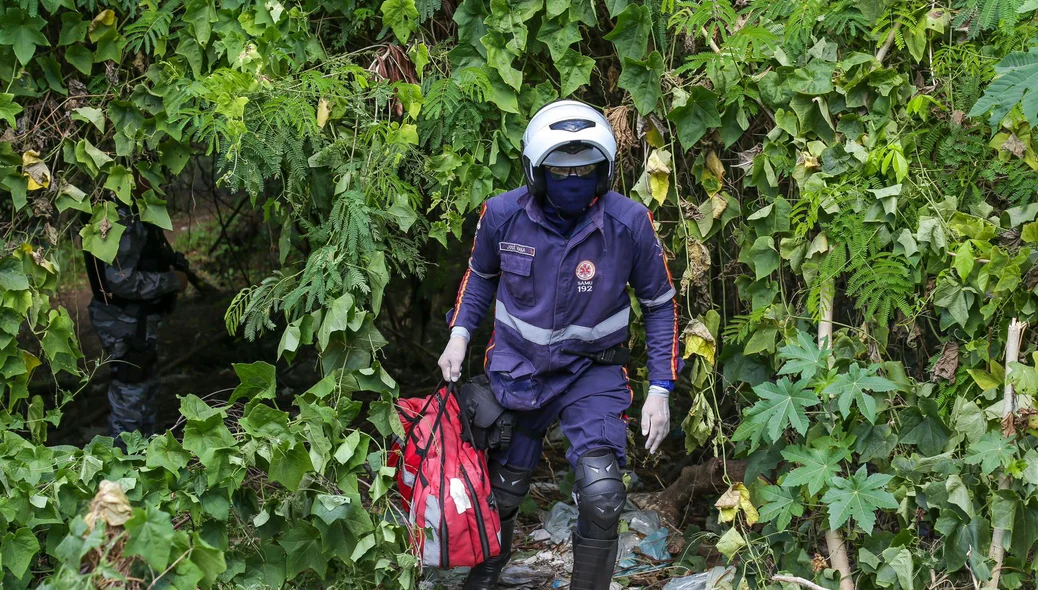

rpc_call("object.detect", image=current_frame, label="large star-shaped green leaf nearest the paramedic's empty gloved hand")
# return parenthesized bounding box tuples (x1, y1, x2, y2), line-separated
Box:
(733, 378, 820, 443)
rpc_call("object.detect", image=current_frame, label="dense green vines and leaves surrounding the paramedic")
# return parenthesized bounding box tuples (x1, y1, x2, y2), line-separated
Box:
(0, 0, 1038, 590)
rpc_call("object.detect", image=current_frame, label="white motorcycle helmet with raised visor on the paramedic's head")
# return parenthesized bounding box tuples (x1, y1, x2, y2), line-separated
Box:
(522, 100, 617, 196)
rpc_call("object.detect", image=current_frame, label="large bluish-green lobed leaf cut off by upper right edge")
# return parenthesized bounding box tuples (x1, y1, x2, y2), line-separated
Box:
(969, 47, 1038, 129)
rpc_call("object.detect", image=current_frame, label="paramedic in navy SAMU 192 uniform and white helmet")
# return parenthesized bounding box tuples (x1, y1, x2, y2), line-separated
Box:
(439, 100, 682, 590)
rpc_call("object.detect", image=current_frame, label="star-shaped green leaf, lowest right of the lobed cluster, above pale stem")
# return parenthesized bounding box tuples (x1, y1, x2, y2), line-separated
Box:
(822, 465, 898, 535)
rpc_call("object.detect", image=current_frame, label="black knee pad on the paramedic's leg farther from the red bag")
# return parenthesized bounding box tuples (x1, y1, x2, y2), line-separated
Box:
(576, 449, 627, 540)
